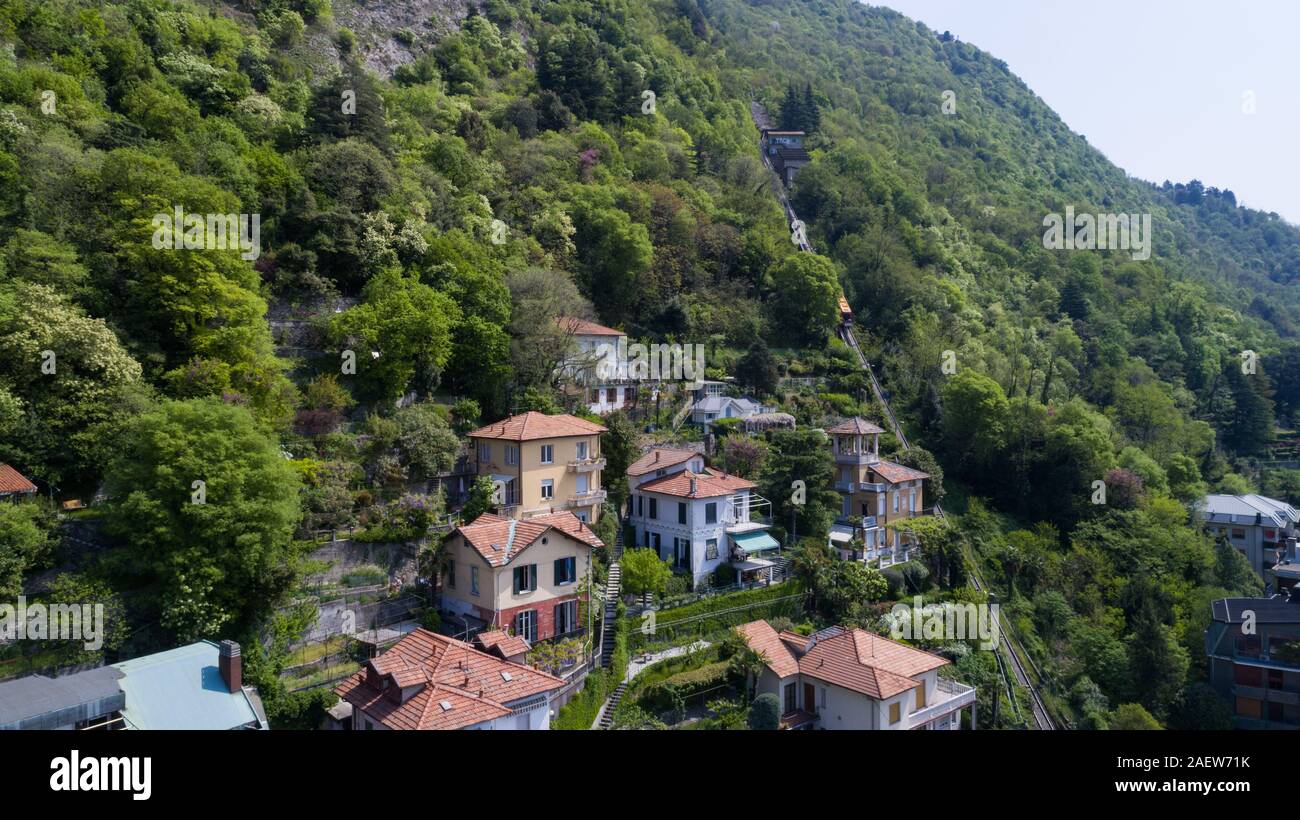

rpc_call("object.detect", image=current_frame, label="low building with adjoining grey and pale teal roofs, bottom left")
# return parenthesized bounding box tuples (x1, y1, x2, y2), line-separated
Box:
(0, 641, 269, 729)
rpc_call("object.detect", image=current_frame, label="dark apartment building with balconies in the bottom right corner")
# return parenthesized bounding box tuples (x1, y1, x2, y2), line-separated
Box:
(1205, 590, 1300, 729)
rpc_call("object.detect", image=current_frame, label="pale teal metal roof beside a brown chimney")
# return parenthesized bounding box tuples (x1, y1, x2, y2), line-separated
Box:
(113, 641, 265, 729)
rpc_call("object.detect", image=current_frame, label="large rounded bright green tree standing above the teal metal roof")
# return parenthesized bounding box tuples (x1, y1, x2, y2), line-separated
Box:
(104, 399, 300, 641)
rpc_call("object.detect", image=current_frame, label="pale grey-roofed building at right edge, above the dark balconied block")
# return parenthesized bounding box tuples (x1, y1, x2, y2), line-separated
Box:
(1197, 494, 1300, 581)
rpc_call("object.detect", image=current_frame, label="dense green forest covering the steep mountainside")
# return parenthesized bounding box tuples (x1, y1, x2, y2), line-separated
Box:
(0, 0, 1300, 726)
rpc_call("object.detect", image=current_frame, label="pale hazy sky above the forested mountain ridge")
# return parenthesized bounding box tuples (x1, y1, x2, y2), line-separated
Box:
(872, 0, 1300, 225)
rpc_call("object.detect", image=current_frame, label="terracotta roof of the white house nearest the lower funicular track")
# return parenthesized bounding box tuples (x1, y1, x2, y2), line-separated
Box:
(737, 621, 948, 700)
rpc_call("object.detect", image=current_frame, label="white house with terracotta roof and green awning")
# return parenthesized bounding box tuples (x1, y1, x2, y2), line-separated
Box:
(627, 450, 780, 585)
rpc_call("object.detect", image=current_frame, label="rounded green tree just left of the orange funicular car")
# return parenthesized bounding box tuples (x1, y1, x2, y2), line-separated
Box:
(768, 253, 840, 346)
